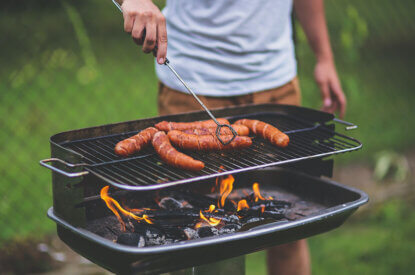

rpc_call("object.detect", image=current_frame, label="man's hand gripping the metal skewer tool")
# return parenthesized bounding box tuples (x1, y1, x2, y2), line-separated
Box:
(121, 0, 167, 64)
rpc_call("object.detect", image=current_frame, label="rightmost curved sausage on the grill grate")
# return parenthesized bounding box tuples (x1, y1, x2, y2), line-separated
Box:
(235, 119, 290, 147)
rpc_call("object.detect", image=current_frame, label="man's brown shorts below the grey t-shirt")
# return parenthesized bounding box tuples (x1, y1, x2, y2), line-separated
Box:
(158, 77, 301, 115)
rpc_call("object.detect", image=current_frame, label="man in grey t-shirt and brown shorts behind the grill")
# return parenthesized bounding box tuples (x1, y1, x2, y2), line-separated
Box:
(117, 0, 346, 274)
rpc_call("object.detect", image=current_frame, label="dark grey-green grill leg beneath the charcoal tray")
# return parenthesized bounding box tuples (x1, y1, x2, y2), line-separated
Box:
(169, 255, 245, 275)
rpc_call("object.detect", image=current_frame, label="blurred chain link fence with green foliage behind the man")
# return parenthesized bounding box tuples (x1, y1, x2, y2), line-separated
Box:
(0, 0, 415, 248)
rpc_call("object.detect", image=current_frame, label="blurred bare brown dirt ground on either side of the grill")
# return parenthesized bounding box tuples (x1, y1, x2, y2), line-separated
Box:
(25, 151, 415, 275)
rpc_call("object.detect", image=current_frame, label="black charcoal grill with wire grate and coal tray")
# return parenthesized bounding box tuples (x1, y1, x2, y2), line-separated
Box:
(41, 104, 368, 274)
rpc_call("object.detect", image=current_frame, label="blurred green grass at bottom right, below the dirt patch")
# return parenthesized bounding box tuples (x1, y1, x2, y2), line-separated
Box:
(246, 200, 415, 275)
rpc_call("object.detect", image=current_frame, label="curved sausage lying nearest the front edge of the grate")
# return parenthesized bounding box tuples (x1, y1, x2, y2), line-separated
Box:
(152, 131, 205, 171)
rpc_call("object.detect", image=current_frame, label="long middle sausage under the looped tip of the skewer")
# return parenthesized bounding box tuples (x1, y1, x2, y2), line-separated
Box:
(168, 130, 252, 151)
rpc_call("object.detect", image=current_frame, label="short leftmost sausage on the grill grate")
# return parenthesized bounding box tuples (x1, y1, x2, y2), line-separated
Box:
(114, 127, 158, 157)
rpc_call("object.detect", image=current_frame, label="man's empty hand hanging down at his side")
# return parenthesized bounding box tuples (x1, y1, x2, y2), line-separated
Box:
(314, 61, 346, 118)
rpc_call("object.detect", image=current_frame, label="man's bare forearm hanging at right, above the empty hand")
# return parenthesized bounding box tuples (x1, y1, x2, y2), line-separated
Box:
(294, 0, 333, 62)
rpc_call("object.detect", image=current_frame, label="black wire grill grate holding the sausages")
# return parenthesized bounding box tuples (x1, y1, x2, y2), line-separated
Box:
(61, 113, 361, 190)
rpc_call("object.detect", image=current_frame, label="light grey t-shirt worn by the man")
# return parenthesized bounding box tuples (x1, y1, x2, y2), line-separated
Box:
(156, 0, 297, 96)
